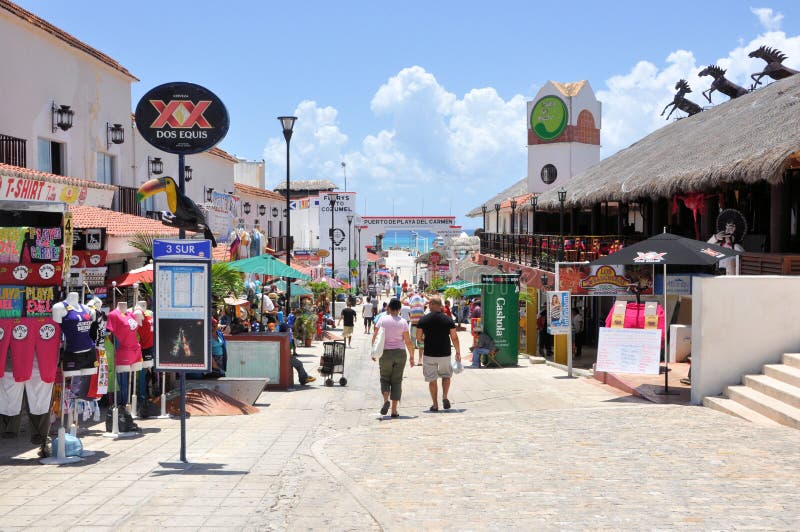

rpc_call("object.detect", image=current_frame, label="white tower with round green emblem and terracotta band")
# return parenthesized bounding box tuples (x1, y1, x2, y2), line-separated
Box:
(527, 80, 601, 193)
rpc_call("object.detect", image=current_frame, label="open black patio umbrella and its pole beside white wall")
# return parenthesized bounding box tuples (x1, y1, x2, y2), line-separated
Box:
(589, 233, 741, 394)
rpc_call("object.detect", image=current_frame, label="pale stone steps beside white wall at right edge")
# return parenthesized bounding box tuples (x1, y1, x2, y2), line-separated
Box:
(703, 353, 800, 429)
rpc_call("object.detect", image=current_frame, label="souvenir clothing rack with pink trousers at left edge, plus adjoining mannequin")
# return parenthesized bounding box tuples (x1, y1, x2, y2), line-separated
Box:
(0, 201, 97, 463)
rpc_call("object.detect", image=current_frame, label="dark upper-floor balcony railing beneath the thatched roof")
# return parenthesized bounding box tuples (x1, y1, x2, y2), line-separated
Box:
(480, 233, 641, 271)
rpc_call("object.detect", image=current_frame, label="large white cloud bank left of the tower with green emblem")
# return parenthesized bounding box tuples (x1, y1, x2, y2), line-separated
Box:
(265, 66, 526, 220)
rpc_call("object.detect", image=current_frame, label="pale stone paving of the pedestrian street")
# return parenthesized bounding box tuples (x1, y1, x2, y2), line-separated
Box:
(0, 326, 800, 530)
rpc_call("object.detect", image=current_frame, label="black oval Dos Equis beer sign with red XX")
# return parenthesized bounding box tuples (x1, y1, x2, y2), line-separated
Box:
(136, 82, 230, 155)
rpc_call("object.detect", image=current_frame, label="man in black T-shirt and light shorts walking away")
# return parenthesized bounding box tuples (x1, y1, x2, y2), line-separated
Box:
(411, 296, 461, 412)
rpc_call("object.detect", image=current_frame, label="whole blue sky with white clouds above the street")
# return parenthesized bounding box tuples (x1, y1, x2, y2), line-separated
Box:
(18, 0, 800, 228)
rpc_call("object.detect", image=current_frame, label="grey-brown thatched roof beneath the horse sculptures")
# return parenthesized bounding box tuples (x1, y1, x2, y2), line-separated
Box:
(538, 75, 800, 209)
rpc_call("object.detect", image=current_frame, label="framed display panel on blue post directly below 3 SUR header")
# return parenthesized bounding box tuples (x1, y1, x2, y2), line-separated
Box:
(153, 260, 211, 371)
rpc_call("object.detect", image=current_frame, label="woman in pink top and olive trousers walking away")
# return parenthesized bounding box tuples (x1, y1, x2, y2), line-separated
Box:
(372, 299, 414, 417)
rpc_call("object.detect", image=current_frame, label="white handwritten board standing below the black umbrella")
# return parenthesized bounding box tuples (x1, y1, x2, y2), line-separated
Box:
(595, 327, 661, 375)
